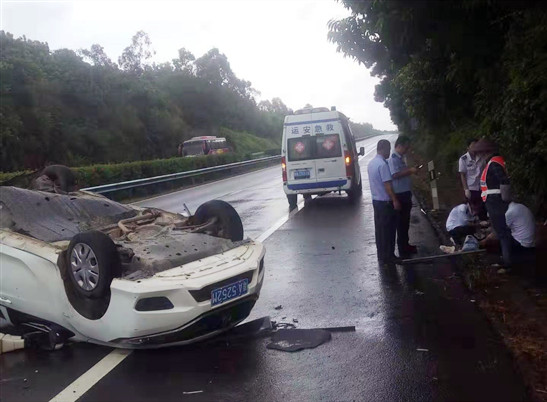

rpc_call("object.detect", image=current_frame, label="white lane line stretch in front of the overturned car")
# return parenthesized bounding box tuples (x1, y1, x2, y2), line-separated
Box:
(50, 349, 132, 402)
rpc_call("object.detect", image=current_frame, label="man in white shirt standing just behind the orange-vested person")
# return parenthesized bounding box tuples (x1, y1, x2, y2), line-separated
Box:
(458, 138, 488, 221)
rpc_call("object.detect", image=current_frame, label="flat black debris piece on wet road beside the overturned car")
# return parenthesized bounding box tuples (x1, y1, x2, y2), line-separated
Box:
(266, 329, 332, 352)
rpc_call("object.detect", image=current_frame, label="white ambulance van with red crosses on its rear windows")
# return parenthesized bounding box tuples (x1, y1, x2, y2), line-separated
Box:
(281, 107, 365, 208)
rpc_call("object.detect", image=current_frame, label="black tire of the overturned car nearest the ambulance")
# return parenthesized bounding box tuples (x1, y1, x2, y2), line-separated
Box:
(194, 200, 243, 241)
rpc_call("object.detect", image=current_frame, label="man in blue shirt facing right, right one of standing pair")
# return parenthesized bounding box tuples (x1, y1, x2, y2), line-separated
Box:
(388, 135, 418, 257)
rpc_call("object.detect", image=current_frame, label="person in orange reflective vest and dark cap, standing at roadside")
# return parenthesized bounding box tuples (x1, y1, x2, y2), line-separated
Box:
(472, 139, 513, 269)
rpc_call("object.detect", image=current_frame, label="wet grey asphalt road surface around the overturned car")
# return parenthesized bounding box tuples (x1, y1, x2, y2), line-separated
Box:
(0, 138, 526, 401)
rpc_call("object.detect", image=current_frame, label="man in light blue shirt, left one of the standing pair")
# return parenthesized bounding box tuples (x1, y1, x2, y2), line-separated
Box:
(367, 140, 401, 266)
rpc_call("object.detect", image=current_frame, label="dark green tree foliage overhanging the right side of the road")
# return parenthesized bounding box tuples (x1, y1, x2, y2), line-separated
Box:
(329, 0, 547, 213)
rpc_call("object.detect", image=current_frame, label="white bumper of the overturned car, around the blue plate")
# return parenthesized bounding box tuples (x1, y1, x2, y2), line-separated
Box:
(65, 243, 265, 348)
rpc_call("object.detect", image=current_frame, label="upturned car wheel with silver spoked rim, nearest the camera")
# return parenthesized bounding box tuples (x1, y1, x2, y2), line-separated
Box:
(67, 230, 120, 299)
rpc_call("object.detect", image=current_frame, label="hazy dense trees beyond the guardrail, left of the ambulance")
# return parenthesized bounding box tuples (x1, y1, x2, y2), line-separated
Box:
(0, 31, 290, 171)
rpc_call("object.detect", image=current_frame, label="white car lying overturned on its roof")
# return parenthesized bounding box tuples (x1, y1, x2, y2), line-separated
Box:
(0, 171, 265, 348)
